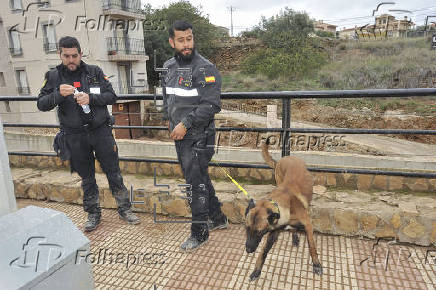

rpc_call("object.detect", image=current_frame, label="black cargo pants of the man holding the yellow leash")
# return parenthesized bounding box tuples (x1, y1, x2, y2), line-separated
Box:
(175, 134, 223, 241)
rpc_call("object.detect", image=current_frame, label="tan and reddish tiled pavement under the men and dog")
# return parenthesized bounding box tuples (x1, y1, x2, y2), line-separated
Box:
(18, 199, 436, 289)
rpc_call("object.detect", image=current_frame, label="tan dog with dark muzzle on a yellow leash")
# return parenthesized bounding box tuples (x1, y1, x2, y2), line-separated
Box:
(245, 138, 322, 281)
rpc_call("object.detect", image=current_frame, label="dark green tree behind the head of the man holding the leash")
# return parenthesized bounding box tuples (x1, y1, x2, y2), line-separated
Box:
(144, 1, 222, 87)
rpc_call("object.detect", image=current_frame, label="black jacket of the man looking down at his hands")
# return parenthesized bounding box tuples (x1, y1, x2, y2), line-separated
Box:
(37, 61, 117, 132)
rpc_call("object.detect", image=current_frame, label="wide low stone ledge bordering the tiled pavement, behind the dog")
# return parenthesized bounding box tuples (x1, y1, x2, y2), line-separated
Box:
(12, 167, 436, 246)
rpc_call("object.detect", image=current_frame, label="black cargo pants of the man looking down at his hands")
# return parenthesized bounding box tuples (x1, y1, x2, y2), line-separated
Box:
(66, 124, 131, 213)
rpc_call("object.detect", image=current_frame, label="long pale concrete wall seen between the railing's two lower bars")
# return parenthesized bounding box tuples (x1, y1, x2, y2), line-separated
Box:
(5, 132, 436, 171)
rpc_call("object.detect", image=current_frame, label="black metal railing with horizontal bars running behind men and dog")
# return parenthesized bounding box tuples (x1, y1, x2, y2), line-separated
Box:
(0, 89, 436, 178)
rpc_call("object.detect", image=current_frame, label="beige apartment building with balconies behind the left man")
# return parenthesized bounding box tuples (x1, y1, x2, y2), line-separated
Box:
(0, 0, 148, 124)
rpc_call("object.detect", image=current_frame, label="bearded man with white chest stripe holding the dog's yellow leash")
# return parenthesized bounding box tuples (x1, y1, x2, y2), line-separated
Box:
(164, 20, 228, 251)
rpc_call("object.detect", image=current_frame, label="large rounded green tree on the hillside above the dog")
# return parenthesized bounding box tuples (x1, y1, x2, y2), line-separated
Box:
(243, 7, 325, 78)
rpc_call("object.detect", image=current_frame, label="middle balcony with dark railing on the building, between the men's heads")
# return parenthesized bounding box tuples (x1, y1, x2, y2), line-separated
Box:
(106, 37, 148, 61)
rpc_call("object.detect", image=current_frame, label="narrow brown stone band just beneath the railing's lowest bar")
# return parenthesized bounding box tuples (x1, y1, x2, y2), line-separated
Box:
(9, 155, 436, 192)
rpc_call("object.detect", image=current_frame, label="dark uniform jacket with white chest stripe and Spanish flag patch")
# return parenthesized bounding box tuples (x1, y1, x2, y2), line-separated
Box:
(163, 51, 221, 138)
